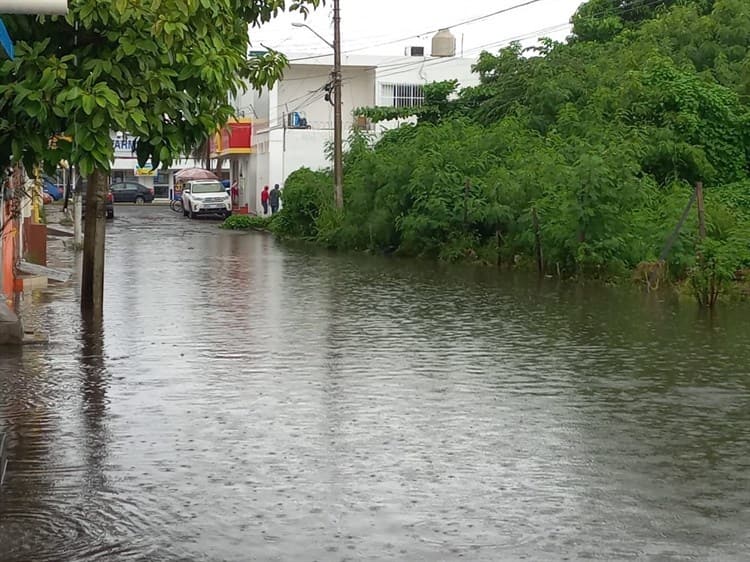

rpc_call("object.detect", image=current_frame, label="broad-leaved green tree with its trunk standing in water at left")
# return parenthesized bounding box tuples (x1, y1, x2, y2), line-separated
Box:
(0, 0, 322, 314)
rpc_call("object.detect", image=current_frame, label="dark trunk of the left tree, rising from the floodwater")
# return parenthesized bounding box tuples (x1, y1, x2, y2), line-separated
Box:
(81, 170, 108, 318)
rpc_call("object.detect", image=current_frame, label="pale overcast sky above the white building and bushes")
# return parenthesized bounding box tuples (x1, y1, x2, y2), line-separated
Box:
(250, 0, 582, 58)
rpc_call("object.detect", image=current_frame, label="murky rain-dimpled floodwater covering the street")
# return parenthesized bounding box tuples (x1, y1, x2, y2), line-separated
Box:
(0, 206, 750, 562)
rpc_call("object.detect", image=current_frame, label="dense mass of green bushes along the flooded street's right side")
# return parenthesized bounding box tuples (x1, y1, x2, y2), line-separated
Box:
(276, 0, 750, 300)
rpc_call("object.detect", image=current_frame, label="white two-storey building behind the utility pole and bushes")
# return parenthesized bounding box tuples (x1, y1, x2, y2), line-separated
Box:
(225, 36, 478, 212)
